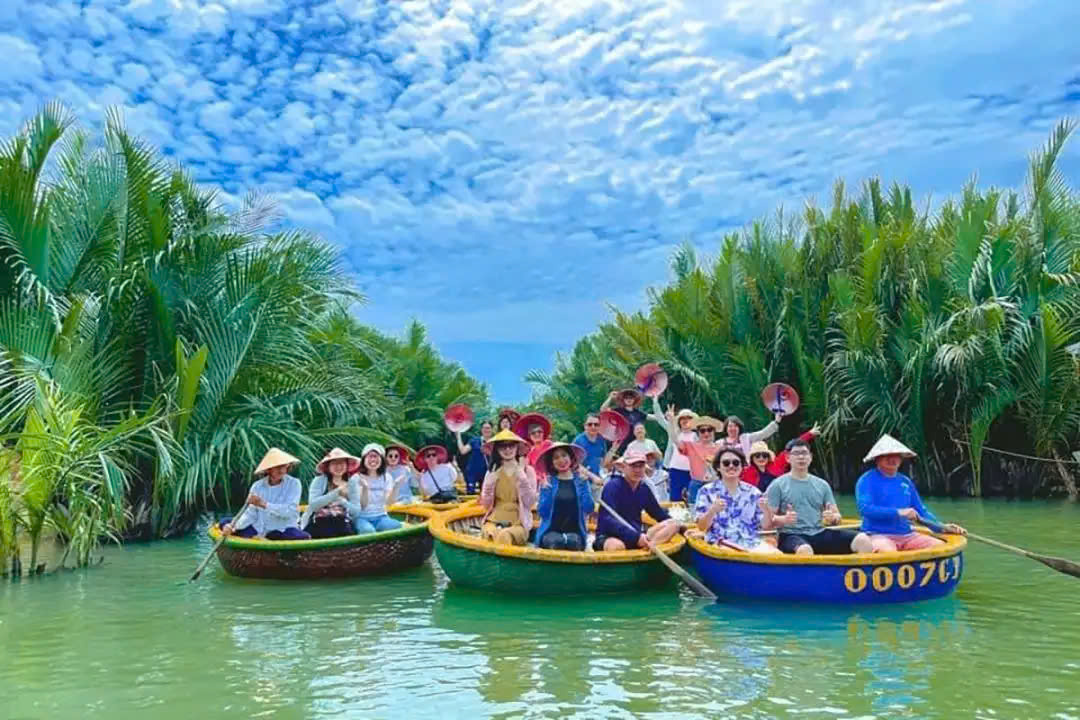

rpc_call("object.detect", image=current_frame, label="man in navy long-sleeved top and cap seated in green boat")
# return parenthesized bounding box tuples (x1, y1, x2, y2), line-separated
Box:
(593, 452, 679, 551)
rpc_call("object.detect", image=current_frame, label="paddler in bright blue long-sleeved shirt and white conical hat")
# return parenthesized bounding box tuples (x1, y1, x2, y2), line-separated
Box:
(855, 435, 967, 553)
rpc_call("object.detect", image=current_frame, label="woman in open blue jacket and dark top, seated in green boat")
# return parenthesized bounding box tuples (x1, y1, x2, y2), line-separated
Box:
(537, 443, 596, 551)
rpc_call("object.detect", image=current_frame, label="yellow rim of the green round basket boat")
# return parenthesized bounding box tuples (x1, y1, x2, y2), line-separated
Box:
(428, 505, 686, 565)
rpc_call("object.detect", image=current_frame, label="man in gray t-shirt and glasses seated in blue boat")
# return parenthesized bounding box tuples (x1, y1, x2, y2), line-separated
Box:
(765, 439, 874, 555)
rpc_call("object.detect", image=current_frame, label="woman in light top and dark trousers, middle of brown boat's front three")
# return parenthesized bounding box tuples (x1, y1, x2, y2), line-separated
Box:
(300, 448, 361, 538)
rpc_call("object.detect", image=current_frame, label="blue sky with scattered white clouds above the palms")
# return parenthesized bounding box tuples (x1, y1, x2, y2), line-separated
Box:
(0, 0, 1080, 400)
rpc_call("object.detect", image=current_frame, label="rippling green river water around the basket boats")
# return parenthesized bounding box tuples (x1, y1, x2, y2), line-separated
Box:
(0, 499, 1080, 720)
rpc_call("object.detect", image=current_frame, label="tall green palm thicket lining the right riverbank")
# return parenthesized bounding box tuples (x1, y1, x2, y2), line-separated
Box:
(527, 122, 1080, 500)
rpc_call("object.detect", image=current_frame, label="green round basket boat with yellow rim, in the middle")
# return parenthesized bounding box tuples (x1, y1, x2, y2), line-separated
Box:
(431, 505, 686, 595)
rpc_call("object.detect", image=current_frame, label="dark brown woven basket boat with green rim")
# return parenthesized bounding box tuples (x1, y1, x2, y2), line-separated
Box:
(208, 505, 434, 580)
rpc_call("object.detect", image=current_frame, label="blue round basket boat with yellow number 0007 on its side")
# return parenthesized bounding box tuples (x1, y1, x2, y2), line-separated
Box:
(687, 532, 968, 604)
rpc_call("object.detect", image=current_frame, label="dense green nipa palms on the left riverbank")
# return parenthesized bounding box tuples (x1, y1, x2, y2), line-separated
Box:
(0, 105, 488, 572)
